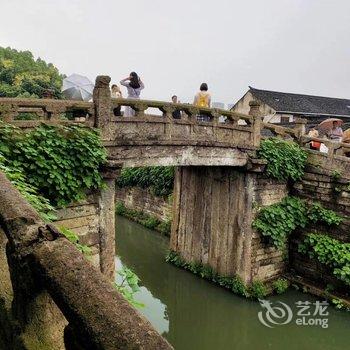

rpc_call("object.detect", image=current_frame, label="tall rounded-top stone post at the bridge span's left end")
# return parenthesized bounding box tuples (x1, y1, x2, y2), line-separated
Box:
(93, 75, 112, 140)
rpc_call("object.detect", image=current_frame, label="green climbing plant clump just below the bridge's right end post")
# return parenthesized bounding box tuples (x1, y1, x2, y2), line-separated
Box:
(258, 138, 307, 181)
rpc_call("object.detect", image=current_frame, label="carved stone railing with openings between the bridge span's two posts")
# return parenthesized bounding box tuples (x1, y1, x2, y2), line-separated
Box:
(109, 99, 257, 148)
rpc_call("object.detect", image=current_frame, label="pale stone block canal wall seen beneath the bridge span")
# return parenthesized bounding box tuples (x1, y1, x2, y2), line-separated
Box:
(116, 187, 172, 221)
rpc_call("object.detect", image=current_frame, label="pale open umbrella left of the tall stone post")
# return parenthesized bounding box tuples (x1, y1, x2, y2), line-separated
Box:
(62, 74, 94, 101)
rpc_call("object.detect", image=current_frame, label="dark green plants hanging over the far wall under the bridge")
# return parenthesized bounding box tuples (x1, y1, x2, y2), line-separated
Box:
(117, 166, 174, 196)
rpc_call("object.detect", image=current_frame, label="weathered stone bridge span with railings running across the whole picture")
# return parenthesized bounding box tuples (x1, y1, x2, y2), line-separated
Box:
(0, 76, 350, 166)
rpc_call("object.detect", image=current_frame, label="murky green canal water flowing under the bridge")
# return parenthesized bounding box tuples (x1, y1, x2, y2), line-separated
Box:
(116, 217, 350, 350)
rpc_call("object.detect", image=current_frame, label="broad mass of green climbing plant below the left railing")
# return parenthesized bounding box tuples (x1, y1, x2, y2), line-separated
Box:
(0, 123, 106, 206)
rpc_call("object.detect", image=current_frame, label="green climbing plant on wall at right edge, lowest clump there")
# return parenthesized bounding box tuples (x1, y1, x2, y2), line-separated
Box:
(298, 233, 350, 286)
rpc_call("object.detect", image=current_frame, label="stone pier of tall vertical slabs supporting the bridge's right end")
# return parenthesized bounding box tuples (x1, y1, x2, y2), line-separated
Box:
(170, 167, 287, 284)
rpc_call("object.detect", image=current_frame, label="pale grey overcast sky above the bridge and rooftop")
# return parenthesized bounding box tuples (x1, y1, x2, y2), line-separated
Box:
(0, 0, 350, 103)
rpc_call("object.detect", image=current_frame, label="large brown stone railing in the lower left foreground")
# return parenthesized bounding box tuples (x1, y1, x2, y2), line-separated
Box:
(0, 173, 172, 350)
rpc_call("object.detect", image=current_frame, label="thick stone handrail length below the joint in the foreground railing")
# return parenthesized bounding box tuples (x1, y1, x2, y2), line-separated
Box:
(31, 238, 171, 350)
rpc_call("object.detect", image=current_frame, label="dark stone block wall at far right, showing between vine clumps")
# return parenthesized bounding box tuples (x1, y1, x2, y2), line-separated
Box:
(289, 166, 350, 291)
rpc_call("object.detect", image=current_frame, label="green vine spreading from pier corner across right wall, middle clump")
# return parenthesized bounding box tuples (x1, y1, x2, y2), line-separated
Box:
(253, 197, 343, 248)
